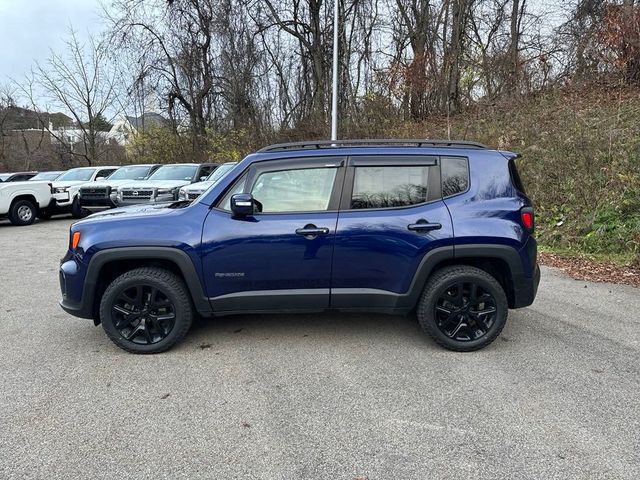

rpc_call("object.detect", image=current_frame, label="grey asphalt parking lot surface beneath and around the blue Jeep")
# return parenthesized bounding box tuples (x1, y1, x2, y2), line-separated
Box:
(0, 218, 640, 479)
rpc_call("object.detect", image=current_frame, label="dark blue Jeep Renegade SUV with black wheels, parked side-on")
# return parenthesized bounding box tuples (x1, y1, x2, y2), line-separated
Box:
(60, 140, 540, 353)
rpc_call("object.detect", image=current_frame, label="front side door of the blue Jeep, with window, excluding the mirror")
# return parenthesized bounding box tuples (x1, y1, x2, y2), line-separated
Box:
(202, 158, 344, 313)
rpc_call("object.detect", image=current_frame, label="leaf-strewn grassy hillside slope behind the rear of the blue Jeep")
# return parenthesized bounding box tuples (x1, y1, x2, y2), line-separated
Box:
(364, 86, 640, 263)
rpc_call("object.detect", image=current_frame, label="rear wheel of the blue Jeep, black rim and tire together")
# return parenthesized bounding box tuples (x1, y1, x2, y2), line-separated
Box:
(417, 265, 509, 352)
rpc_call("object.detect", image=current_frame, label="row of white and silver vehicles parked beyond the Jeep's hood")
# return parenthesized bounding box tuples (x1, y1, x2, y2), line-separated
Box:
(0, 162, 235, 225)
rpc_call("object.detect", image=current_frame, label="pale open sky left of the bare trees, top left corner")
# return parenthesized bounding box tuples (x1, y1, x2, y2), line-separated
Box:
(0, 0, 101, 84)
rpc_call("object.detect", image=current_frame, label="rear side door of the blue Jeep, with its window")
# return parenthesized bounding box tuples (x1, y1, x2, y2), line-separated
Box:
(331, 155, 453, 309)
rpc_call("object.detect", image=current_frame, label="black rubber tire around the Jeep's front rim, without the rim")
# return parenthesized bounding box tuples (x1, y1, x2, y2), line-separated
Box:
(100, 275, 192, 353)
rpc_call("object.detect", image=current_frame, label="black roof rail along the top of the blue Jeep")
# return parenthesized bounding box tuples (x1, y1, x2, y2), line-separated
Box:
(258, 138, 489, 153)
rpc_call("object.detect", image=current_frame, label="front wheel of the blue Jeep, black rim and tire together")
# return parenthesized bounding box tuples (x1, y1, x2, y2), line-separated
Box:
(100, 267, 193, 353)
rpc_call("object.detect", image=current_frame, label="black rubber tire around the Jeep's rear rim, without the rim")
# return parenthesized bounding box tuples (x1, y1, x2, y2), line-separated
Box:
(420, 273, 509, 350)
